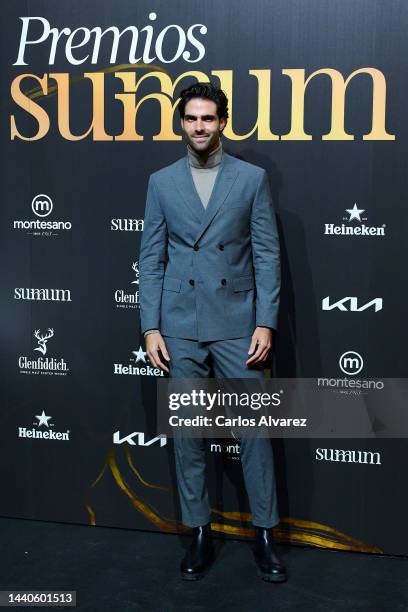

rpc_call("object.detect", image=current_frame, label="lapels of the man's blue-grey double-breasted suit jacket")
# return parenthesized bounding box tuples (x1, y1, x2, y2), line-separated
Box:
(173, 152, 238, 242)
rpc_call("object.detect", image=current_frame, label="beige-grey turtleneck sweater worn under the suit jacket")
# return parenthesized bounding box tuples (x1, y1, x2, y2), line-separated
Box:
(144, 139, 223, 337)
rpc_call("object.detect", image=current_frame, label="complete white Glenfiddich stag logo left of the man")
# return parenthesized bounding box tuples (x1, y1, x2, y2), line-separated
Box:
(18, 327, 69, 376)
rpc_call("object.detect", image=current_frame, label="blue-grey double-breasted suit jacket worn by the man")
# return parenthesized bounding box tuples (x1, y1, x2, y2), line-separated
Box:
(139, 151, 280, 342)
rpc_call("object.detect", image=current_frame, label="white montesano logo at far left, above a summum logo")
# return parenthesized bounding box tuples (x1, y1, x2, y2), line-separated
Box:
(13, 193, 72, 237)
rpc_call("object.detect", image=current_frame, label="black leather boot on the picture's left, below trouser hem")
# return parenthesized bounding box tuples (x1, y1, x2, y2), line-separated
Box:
(180, 523, 214, 580)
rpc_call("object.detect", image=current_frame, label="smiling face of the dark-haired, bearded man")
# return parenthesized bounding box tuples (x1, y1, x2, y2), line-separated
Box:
(181, 98, 227, 154)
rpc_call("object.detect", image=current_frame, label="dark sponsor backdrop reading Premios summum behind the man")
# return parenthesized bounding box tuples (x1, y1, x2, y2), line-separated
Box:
(0, 0, 408, 554)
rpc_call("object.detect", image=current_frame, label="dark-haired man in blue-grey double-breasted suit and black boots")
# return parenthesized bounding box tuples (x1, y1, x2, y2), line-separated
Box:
(139, 83, 287, 582)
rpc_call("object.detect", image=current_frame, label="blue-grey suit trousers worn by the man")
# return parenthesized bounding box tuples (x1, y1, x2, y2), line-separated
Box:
(164, 336, 279, 527)
